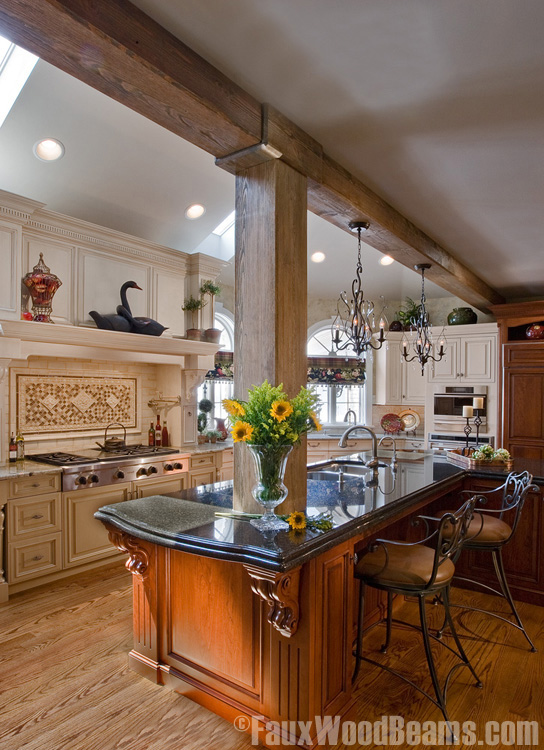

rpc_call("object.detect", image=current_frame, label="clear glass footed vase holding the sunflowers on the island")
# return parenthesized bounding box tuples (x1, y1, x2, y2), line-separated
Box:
(247, 445, 293, 531)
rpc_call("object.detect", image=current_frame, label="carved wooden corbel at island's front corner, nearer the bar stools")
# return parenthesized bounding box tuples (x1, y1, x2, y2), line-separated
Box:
(244, 565, 300, 638)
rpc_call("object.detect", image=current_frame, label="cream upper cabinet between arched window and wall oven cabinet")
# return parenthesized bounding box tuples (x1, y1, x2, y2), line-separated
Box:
(374, 332, 426, 406)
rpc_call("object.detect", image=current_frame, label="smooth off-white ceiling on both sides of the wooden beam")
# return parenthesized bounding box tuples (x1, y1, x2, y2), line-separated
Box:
(0, 0, 544, 306)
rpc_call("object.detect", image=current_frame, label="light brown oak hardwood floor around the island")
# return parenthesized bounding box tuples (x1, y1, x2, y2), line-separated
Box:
(0, 564, 544, 750)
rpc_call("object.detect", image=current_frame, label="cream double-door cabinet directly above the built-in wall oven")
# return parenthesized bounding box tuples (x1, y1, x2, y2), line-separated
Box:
(427, 323, 498, 385)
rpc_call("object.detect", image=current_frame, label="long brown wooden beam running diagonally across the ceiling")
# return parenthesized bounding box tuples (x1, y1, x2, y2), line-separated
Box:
(0, 0, 504, 310)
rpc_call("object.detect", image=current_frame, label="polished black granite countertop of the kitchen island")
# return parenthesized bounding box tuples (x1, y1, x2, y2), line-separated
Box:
(95, 456, 482, 571)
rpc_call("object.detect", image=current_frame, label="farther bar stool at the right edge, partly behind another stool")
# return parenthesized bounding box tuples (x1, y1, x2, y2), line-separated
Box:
(437, 471, 538, 651)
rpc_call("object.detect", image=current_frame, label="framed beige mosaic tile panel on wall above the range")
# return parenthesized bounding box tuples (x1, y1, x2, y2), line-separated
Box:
(17, 374, 138, 435)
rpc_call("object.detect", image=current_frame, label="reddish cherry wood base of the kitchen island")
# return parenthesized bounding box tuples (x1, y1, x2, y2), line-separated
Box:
(98, 467, 478, 748)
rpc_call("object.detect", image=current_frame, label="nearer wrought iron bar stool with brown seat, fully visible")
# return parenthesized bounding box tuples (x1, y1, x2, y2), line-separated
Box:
(352, 498, 482, 735)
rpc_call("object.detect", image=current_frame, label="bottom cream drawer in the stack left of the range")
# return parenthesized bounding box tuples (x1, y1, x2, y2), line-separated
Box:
(8, 531, 62, 583)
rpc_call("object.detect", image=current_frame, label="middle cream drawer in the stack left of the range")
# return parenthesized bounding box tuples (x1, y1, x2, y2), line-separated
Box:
(8, 493, 62, 542)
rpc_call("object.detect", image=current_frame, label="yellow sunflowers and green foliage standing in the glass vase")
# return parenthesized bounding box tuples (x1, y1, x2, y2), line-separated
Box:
(223, 380, 321, 446)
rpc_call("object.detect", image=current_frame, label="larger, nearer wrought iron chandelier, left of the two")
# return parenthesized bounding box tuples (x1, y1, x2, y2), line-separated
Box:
(331, 221, 387, 359)
